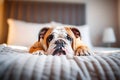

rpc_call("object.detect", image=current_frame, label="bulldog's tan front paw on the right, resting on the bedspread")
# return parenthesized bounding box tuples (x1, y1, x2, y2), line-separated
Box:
(75, 46, 93, 56)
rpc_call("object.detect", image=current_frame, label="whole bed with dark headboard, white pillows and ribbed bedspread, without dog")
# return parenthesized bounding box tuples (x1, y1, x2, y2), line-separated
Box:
(0, 0, 120, 80)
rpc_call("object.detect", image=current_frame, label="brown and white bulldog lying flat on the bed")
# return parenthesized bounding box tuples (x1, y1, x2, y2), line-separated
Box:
(29, 26, 93, 56)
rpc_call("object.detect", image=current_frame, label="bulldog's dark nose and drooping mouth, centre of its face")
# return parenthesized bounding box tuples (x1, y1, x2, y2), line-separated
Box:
(53, 39, 66, 55)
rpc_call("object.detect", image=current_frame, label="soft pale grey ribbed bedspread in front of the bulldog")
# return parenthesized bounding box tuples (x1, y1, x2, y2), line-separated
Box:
(0, 45, 120, 80)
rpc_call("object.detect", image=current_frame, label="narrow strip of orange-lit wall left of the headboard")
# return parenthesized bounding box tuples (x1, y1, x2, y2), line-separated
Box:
(0, 0, 4, 43)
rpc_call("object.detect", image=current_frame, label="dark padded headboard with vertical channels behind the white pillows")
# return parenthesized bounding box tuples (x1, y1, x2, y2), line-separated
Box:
(2, 0, 86, 42)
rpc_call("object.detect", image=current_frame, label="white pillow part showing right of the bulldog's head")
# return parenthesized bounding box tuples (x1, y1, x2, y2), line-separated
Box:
(77, 25, 93, 49)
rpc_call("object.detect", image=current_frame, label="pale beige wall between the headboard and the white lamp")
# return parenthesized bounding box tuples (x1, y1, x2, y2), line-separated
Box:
(86, 0, 117, 45)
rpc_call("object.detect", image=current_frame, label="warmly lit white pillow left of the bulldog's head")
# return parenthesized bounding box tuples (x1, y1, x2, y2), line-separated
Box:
(7, 19, 50, 47)
